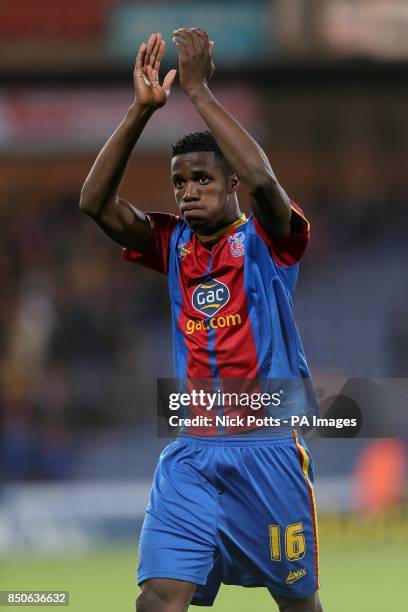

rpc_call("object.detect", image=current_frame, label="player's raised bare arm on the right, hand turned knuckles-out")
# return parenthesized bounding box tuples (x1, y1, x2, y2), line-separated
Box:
(173, 28, 291, 236)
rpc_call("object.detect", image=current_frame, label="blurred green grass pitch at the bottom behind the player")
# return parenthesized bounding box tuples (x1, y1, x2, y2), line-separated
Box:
(0, 541, 406, 612)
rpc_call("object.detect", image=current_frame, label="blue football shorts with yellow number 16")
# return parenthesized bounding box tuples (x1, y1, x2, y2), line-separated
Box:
(138, 432, 318, 606)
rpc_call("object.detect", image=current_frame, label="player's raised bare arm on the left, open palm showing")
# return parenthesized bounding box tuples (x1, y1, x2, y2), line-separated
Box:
(79, 34, 176, 251)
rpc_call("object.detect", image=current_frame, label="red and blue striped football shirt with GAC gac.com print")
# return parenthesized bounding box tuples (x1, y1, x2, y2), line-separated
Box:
(122, 204, 310, 379)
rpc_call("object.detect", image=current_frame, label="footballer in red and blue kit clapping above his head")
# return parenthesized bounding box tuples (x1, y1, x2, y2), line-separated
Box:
(80, 28, 322, 612)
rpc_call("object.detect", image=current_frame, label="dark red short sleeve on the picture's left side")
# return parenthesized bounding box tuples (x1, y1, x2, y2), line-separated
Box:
(122, 213, 179, 274)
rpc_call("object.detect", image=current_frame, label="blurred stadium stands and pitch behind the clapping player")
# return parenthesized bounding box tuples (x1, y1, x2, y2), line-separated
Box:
(0, 0, 408, 612)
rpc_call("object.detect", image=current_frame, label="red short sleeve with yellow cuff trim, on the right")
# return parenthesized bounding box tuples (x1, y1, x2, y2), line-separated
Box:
(254, 202, 310, 266)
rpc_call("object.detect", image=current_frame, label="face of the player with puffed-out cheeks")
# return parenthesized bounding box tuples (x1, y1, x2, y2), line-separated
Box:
(171, 151, 234, 234)
